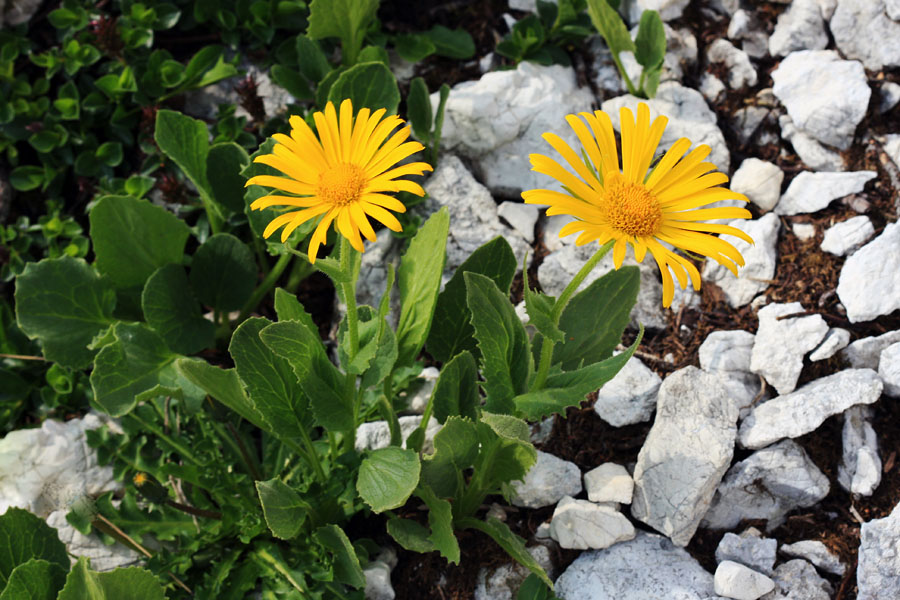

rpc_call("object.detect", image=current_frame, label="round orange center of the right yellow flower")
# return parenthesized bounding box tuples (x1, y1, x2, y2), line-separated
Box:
(604, 173, 662, 237)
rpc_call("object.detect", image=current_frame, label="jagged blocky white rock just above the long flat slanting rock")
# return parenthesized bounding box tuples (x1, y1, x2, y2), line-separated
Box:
(750, 302, 828, 394)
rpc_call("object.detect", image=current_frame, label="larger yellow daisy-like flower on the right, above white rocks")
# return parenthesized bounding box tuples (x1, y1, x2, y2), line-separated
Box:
(522, 103, 753, 306)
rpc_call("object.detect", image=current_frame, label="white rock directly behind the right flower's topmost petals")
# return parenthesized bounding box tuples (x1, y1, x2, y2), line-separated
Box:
(602, 81, 731, 172)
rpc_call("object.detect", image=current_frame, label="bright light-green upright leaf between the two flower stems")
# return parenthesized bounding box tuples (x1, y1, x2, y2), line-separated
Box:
(397, 207, 450, 366)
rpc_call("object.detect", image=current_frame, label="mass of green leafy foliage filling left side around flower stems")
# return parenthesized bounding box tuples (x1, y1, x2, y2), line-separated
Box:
(0, 0, 665, 599)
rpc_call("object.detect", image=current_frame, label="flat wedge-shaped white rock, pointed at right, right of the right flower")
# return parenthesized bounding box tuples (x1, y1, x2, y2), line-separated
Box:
(775, 171, 878, 215)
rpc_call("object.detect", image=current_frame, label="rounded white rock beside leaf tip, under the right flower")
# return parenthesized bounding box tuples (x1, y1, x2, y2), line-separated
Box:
(592, 356, 662, 426)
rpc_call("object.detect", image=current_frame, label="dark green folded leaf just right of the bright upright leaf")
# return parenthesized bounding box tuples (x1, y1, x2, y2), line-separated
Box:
(425, 236, 516, 363)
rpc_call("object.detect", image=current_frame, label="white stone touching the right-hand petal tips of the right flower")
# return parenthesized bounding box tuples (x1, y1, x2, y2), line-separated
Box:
(703, 213, 781, 308)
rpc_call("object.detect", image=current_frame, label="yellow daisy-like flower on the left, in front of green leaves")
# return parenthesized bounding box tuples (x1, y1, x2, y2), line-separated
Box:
(246, 99, 431, 262)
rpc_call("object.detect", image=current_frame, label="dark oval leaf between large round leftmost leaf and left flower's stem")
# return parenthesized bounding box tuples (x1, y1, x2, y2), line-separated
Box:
(141, 264, 216, 354)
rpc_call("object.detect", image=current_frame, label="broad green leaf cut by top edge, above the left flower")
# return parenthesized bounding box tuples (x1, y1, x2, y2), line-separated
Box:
(306, 0, 378, 65)
